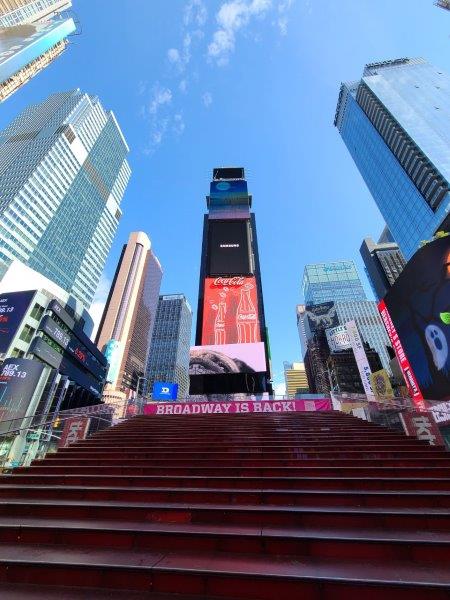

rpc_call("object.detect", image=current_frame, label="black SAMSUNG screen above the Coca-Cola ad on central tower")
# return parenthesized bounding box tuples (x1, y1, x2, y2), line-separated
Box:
(206, 220, 253, 276)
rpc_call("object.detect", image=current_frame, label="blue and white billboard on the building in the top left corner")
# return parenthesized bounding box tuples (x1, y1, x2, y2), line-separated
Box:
(0, 19, 76, 83)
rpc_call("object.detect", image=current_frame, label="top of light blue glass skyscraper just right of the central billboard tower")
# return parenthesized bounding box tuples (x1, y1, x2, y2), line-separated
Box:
(302, 260, 367, 305)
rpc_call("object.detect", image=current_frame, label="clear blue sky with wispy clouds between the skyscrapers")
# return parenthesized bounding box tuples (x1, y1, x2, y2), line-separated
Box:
(0, 0, 450, 390)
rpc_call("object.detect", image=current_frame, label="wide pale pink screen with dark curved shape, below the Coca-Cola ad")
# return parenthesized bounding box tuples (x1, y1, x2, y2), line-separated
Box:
(189, 342, 266, 375)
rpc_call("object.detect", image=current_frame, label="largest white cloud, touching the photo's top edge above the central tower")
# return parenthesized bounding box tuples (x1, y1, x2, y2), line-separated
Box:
(208, 0, 272, 66)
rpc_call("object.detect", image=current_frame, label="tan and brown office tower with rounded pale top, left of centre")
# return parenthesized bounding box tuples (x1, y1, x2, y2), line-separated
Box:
(95, 231, 162, 396)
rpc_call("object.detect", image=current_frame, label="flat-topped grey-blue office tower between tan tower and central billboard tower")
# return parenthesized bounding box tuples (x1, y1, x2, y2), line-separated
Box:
(146, 294, 192, 398)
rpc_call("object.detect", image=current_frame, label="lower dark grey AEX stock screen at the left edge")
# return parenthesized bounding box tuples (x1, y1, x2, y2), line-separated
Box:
(0, 358, 45, 421)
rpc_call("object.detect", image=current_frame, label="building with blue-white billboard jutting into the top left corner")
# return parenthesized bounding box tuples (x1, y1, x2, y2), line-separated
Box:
(0, 0, 76, 102)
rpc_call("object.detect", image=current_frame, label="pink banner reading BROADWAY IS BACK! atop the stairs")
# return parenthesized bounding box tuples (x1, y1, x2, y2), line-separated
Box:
(144, 398, 332, 415)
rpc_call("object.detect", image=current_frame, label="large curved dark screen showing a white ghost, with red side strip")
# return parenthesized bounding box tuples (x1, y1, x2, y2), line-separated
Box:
(378, 236, 450, 402)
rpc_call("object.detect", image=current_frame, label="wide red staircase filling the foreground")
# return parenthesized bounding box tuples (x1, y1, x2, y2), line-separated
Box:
(0, 412, 450, 600)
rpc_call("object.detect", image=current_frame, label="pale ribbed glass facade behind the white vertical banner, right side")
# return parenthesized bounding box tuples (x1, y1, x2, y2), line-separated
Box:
(334, 300, 391, 373)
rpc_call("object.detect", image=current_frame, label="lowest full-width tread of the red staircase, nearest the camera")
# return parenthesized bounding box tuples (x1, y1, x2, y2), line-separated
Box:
(0, 544, 450, 591)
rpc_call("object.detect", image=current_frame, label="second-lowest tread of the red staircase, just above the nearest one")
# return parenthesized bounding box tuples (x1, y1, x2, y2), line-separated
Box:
(0, 517, 450, 544)
